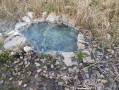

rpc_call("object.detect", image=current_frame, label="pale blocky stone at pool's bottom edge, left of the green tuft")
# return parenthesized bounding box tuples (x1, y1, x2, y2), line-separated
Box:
(62, 52, 77, 66)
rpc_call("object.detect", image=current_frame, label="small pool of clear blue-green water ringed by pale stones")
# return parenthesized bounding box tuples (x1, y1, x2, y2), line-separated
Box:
(21, 21, 78, 53)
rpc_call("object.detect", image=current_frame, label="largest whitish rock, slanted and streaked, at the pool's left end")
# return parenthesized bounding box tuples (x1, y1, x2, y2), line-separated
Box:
(4, 33, 27, 51)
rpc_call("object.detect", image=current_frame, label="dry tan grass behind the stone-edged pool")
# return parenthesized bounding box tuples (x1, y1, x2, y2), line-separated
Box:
(0, 0, 119, 46)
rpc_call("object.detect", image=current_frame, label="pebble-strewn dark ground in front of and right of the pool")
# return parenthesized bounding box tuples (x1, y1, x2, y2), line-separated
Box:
(0, 30, 119, 90)
